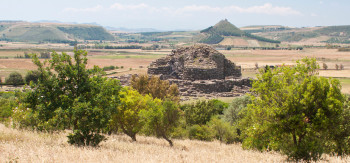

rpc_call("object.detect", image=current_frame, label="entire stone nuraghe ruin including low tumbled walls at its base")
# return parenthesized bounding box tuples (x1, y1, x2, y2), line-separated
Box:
(148, 45, 251, 100)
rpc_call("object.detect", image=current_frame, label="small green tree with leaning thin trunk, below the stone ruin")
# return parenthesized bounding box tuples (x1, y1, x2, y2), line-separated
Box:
(142, 100, 181, 146)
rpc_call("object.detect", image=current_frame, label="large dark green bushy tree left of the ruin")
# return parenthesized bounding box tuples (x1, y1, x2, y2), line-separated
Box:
(15, 50, 121, 146)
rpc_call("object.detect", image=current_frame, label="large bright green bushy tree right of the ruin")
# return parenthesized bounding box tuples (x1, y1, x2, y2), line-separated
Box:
(241, 58, 344, 161)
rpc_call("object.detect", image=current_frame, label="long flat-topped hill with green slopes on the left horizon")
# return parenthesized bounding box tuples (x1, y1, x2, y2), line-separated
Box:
(0, 22, 114, 42)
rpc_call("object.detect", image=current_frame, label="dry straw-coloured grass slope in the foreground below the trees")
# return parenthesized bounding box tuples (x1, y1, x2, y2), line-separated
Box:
(0, 124, 350, 163)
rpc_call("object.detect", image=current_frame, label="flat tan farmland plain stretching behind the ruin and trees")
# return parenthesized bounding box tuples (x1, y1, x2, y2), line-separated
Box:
(0, 44, 350, 93)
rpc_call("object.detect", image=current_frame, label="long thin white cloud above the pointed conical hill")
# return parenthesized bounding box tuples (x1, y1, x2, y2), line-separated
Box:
(176, 3, 302, 16)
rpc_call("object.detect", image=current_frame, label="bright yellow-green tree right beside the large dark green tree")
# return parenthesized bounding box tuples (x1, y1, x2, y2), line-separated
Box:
(113, 87, 160, 141)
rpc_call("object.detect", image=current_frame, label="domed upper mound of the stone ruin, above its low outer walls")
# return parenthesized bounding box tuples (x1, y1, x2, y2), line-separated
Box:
(148, 45, 242, 81)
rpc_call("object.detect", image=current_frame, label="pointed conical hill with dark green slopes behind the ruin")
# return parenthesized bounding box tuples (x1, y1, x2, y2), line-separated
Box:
(199, 19, 280, 46)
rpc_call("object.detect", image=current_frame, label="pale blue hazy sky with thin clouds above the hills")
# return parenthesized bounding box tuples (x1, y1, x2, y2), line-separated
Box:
(0, 0, 350, 30)
